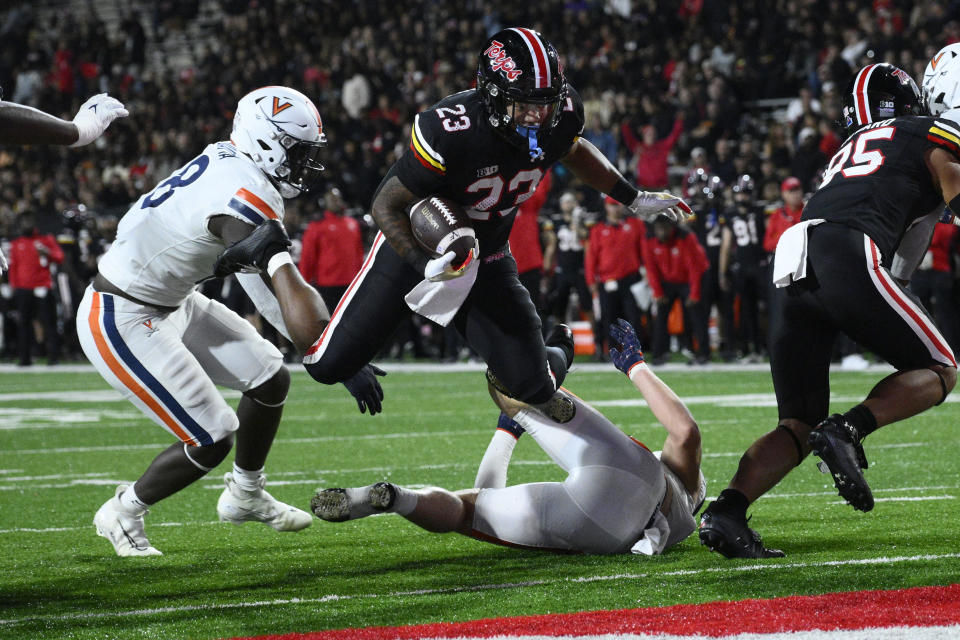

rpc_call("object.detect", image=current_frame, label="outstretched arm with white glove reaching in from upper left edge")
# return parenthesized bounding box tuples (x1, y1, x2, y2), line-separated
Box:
(0, 89, 129, 275)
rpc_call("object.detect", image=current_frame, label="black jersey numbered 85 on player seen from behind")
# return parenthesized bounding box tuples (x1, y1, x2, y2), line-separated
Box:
(803, 116, 960, 267)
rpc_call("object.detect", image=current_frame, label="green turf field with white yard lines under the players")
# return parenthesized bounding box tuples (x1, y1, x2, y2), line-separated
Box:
(0, 365, 960, 640)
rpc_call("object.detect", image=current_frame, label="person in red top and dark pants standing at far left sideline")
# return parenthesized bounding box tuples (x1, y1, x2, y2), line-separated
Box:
(9, 215, 63, 367)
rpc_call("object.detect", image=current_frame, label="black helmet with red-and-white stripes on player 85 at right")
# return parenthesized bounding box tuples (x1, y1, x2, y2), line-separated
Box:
(840, 62, 927, 136)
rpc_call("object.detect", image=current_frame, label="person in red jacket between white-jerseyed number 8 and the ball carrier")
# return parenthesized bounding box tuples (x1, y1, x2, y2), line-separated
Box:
(298, 187, 363, 309)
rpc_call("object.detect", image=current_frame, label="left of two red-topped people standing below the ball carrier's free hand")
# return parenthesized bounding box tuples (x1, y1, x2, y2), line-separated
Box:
(584, 196, 647, 355)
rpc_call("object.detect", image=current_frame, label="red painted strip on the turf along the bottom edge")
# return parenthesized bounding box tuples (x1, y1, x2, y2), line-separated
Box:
(234, 584, 960, 640)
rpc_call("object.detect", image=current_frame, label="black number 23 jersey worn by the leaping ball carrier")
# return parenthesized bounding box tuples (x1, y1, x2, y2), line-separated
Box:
(387, 88, 583, 257)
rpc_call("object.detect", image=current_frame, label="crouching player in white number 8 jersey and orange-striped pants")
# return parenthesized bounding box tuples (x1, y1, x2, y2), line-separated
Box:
(77, 87, 372, 556)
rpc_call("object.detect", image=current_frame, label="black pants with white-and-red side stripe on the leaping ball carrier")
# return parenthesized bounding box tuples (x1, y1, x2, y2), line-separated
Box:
(303, 234, 566, 403)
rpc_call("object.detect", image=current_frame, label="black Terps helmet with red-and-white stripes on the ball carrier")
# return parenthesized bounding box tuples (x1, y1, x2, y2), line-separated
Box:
(477, 27, 567, 161)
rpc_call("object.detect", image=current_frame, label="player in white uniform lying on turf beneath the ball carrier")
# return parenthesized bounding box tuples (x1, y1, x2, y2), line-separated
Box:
(311, 320, 706, 555)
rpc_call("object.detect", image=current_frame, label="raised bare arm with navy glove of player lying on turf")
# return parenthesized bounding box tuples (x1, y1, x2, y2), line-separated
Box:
(610, 318, 701, 494)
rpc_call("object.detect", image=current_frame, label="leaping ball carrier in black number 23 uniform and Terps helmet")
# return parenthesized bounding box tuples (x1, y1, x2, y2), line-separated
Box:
(220, 28, 689, 416)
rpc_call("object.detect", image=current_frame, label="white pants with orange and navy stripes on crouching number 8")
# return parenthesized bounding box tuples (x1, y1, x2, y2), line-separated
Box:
(77, 287, 283, 446)
